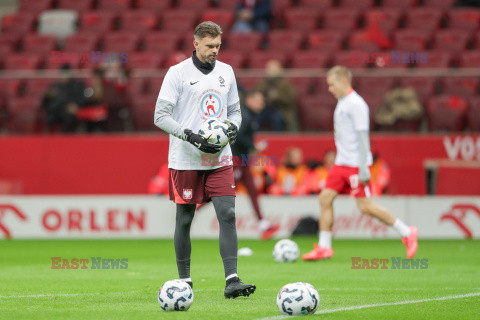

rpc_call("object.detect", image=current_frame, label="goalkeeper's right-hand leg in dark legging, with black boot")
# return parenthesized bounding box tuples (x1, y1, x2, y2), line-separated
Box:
(212, 196, 256, 298)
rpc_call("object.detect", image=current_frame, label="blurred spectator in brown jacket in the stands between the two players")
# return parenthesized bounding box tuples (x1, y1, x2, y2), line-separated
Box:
(257, 60, 298, 131)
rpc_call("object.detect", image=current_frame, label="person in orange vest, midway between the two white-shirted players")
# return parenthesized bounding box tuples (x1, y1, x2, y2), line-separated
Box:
(268, 147, 306, 195)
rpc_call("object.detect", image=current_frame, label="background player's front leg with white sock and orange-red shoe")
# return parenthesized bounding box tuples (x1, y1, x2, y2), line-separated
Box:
(302, 189, 338, 260)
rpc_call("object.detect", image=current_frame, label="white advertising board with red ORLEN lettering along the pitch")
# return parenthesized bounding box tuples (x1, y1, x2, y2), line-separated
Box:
(0, 196, 480, 239)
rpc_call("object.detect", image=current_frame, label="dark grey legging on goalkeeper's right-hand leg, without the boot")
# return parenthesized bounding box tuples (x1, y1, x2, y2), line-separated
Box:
(212, 196, 238, 277)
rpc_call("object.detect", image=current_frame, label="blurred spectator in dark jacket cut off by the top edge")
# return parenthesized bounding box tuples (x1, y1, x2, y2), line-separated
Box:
(232, 0, 272, 33)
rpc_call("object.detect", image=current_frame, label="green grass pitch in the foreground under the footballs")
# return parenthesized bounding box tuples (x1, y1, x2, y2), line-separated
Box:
(0, 237, 480, 320)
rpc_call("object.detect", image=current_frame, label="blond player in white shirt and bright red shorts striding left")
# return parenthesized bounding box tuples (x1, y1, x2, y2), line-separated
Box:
(302, 66, 417, 260)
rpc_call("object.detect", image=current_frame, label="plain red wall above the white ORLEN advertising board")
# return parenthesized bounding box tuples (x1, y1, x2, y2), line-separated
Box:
(0, 134, 480, 195)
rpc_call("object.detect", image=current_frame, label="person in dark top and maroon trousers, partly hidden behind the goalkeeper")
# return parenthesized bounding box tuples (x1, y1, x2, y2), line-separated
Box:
(232, 91, 280, 240)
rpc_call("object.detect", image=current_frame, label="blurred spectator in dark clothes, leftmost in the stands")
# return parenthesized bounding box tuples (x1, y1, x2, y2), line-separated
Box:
(42, 65, 85, 132)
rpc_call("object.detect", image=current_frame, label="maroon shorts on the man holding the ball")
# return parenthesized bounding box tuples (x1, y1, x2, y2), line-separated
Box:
(168, 166, 235, 204)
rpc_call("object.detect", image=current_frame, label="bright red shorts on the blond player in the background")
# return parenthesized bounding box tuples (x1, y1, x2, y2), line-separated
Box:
(325, 165, 371, 198)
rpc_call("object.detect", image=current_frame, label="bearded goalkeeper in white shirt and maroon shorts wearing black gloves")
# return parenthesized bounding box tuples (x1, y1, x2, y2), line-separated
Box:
(154, 21, 256, 298)
